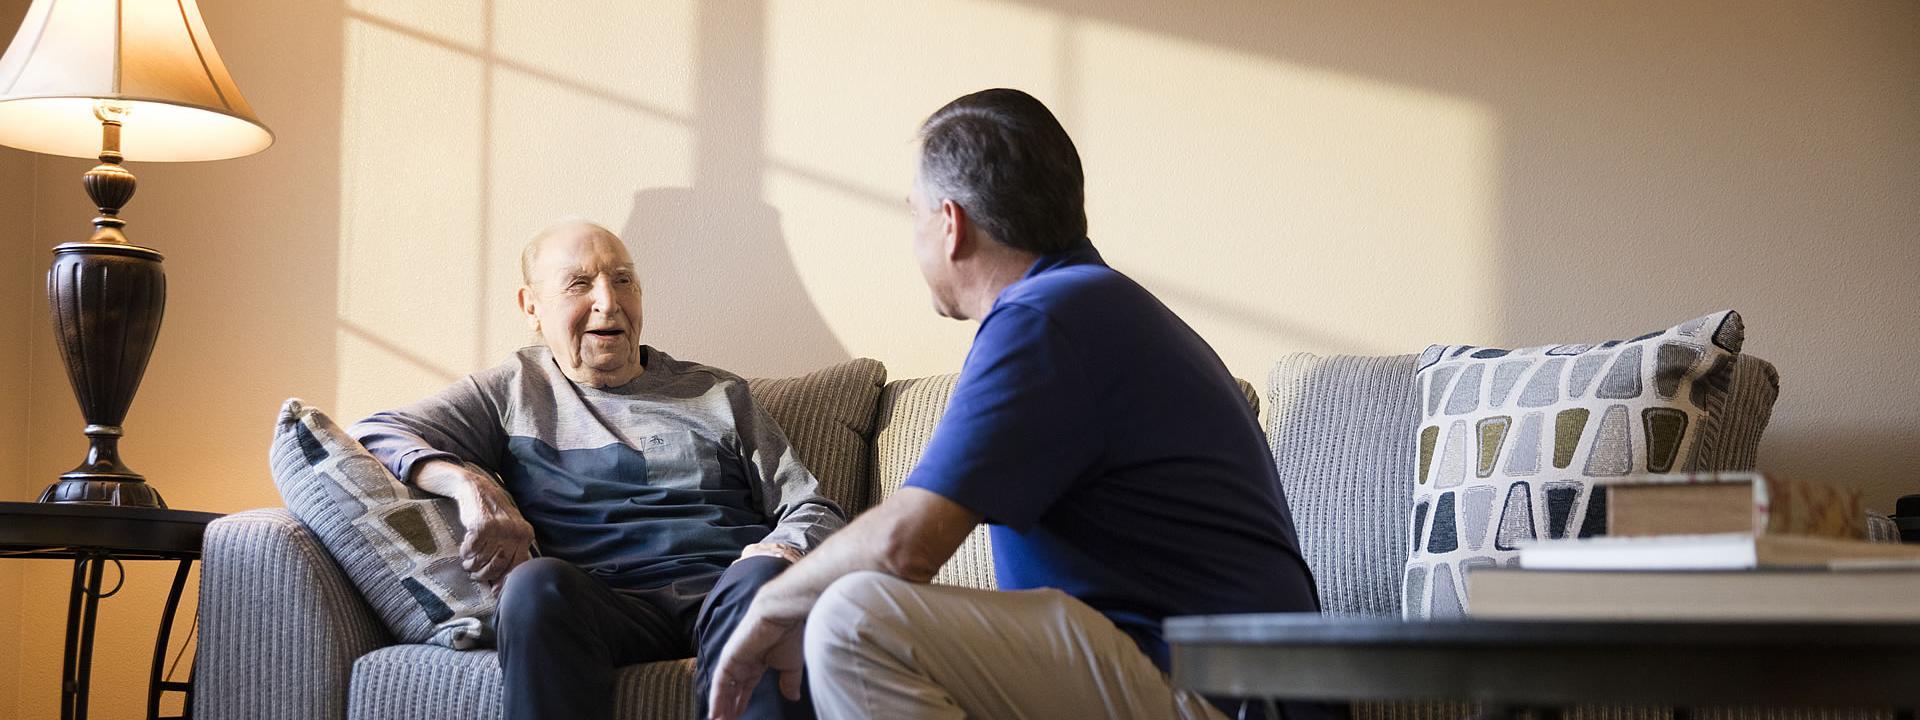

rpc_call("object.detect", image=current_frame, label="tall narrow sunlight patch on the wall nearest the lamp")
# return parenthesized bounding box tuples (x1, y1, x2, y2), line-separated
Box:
(328, 19, 484, 417)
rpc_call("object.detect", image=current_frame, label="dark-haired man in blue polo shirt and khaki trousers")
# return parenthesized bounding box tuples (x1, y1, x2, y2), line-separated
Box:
(712, 90, 1319, 718)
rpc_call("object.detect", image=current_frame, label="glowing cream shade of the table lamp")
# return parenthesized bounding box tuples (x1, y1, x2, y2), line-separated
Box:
(0, 0, 273, 161)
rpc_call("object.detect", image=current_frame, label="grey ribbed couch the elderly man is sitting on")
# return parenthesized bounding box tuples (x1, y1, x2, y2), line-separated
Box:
(194, 355, 1778, 720)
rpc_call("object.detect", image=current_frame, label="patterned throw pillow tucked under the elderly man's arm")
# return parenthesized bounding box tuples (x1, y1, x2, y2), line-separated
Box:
(271, 399, 495, 649)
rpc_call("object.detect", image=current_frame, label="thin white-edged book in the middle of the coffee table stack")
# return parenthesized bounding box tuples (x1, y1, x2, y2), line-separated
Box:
(1519, 532, 1920, 570)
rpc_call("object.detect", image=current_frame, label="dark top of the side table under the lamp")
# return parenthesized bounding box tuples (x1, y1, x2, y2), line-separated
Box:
(0, 503, 221, 559)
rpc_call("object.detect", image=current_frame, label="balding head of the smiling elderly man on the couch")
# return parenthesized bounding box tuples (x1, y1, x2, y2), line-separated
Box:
(520, 227, 641, 388)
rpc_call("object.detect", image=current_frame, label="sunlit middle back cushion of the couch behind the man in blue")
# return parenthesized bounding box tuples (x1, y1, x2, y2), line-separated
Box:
(872, 374, 1260, 589)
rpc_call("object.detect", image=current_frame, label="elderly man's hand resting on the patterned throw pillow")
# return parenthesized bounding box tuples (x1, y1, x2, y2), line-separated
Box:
(413, 461, 534, 593)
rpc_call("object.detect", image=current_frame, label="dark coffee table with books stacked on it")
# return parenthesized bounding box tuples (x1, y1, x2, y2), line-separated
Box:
(1165, 614, 1920, 718)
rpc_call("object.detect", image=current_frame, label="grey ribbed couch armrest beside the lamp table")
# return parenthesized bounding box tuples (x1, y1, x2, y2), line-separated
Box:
(194, 509, 394, 720)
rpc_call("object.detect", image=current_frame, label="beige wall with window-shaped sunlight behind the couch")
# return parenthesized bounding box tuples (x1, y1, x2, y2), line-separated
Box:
(0, 0, 1920, 716)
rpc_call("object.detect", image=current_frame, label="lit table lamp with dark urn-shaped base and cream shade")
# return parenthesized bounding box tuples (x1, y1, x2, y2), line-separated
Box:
(0, 0, 273, 507)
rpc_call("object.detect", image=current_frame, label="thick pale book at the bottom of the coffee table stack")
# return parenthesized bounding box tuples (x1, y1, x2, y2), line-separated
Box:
(1467, 566, 1920, 622)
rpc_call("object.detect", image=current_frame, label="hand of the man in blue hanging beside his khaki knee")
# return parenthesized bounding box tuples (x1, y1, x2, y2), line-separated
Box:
(707, 610, 806, 720)
